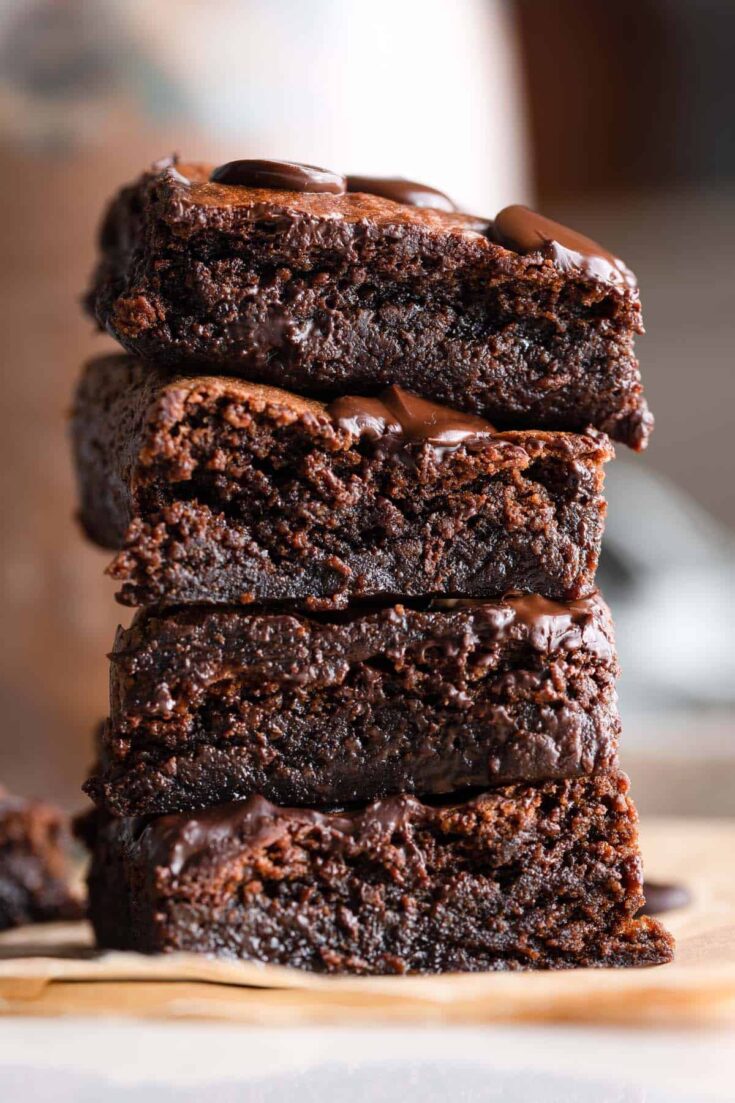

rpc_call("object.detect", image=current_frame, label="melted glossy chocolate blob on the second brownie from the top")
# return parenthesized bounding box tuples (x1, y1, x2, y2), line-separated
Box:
(327, 386, 496, 458)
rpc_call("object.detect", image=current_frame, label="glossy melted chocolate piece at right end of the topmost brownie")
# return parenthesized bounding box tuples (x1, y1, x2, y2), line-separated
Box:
(494, 204, 638, 289)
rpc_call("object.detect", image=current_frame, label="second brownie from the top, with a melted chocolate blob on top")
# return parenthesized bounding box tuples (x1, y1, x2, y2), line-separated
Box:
(73, 356, 611, 608)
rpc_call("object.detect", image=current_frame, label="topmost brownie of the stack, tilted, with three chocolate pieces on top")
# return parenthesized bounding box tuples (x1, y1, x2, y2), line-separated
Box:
(87, 161, 652, 449)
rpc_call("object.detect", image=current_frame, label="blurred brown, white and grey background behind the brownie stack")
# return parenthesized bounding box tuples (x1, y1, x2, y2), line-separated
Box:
(0, 0, 735, 814)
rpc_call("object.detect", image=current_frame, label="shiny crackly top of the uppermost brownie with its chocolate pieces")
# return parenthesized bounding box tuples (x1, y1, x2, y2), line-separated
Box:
(110, 158, 637, 293)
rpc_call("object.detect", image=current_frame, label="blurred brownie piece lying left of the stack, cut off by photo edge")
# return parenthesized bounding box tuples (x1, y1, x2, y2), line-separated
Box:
(0, 786, 83, 931)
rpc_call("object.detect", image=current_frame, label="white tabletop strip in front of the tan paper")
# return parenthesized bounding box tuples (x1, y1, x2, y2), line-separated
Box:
(0, 1018, 735, 1103)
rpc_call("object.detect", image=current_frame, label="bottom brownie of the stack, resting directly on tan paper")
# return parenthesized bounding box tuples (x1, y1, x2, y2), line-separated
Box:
(88, 774, 673, 974)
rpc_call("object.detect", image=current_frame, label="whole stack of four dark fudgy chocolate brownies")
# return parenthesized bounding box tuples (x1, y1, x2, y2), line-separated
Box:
(74, 158, 672, 973)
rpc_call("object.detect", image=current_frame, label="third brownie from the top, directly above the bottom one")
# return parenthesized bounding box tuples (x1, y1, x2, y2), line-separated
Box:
(85, 595, 619, 816)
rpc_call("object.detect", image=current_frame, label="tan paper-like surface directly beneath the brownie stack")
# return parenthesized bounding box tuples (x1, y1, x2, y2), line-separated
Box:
(0, 818, 735, 1025)
